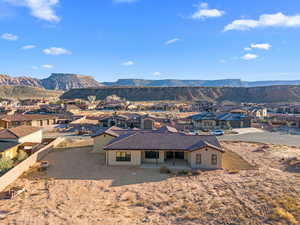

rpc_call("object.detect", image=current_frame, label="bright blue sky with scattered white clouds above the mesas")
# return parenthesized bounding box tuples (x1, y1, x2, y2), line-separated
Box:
(0, 0, 300, 81)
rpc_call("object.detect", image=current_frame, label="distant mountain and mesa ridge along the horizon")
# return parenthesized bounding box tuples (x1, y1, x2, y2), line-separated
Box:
(0, 73, 300, 91)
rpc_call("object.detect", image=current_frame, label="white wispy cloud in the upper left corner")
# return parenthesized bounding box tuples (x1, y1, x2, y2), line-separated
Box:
(5, 0, 60, 22)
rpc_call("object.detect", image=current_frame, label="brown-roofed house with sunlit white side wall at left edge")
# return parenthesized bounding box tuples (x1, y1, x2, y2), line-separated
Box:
(0, 125, 43, 143)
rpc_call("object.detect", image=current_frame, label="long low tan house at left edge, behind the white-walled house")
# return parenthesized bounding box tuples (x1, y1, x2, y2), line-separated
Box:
(0, 114, 58, 128)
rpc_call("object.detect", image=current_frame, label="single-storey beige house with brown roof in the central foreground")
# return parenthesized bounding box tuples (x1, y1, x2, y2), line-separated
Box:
(103, 131, 224, 169)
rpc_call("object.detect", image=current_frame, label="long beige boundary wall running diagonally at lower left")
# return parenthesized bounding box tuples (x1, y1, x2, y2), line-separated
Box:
(0, 137, 64, 191)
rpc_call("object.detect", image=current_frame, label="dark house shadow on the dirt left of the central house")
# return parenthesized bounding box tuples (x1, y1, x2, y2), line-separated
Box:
(44, 147, 170, 186)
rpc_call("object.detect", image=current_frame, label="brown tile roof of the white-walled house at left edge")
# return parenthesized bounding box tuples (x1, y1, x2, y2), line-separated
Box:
(0, 125, 41, 139)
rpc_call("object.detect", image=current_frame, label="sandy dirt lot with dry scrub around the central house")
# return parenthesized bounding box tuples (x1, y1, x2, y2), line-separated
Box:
(0, 142, 300, 225)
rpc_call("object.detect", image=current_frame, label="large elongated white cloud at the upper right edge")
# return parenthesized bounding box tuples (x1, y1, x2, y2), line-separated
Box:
(224, 12, 300, 31)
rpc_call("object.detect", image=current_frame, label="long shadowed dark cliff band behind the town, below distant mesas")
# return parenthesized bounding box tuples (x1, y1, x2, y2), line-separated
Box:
(61, 86, 300, 103)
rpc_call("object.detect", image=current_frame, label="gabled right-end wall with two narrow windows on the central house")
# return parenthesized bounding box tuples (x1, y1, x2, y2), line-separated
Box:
(189, 147, 222, 169)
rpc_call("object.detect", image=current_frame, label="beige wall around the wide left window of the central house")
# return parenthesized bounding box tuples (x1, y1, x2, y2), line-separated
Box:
(106, 150, 142, 166)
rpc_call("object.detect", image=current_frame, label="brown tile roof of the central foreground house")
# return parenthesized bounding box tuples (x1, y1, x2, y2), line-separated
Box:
(104, 131, 224, 152)
